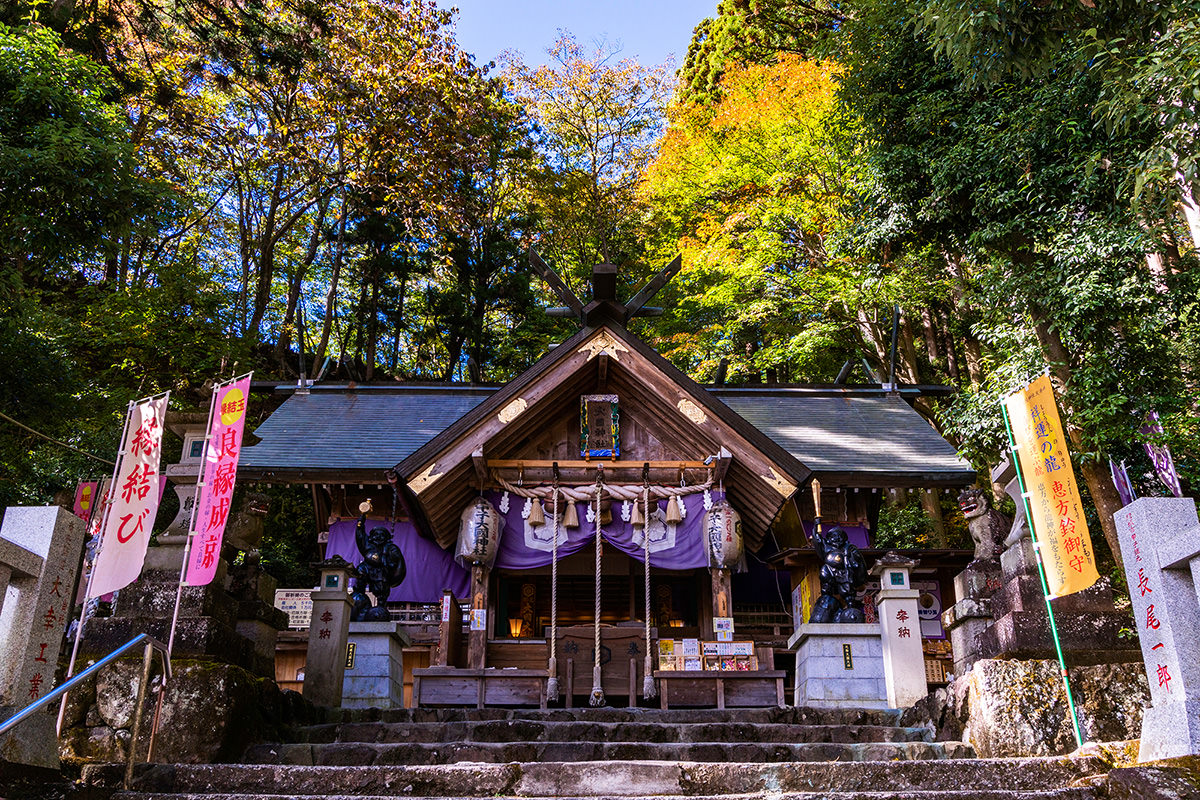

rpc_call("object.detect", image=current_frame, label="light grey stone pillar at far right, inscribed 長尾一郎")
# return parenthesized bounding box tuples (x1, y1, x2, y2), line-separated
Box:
(1116, 498, 1200, 762)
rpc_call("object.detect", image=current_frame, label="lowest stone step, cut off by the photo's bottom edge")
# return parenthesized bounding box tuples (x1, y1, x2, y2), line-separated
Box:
(113, 788, 1097, 800)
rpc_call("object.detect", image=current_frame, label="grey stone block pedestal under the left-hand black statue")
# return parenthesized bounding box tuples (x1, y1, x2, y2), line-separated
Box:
(342, 622, 409, 709)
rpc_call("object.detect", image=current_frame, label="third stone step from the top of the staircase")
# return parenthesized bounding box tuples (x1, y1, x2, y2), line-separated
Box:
(244, 741, 974, 766)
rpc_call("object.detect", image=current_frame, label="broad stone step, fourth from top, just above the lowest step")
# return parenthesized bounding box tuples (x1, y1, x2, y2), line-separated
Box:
(82, 757, 1106, 798)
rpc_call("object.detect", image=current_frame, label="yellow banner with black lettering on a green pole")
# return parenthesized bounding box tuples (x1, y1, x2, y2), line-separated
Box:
(1004, 375, 1100, 597)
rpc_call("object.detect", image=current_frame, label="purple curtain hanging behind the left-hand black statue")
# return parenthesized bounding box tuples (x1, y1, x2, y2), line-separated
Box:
(325, 519, 470, 603)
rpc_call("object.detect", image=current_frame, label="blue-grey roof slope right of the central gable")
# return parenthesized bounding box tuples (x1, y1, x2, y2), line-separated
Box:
(713, 390, 973, 477)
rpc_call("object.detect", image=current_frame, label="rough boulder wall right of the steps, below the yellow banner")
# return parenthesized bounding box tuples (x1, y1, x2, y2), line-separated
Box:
(901, 660, 1150, 758)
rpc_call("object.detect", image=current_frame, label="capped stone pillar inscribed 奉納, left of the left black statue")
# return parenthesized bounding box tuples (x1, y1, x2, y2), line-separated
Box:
(304, 555, 356, 708)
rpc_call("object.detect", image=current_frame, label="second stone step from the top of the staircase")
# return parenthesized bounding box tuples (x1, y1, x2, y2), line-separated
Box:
(294, 720, 932, 744)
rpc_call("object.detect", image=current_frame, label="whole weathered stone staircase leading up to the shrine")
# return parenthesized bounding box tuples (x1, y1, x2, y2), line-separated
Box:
(83, 708, 1108, 800)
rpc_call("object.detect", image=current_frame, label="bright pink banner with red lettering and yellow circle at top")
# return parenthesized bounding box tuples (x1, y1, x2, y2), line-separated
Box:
(184, 374, 250, 587)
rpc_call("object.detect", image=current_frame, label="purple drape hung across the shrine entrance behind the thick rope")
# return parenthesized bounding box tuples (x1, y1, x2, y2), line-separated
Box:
(488, 491, 722, 570)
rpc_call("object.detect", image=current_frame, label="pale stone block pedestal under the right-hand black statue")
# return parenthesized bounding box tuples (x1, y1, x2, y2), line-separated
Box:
(787, 622, 889, 709)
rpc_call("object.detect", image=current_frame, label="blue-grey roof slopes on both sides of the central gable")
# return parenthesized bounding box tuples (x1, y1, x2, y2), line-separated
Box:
(240, 386, 973, 482)
